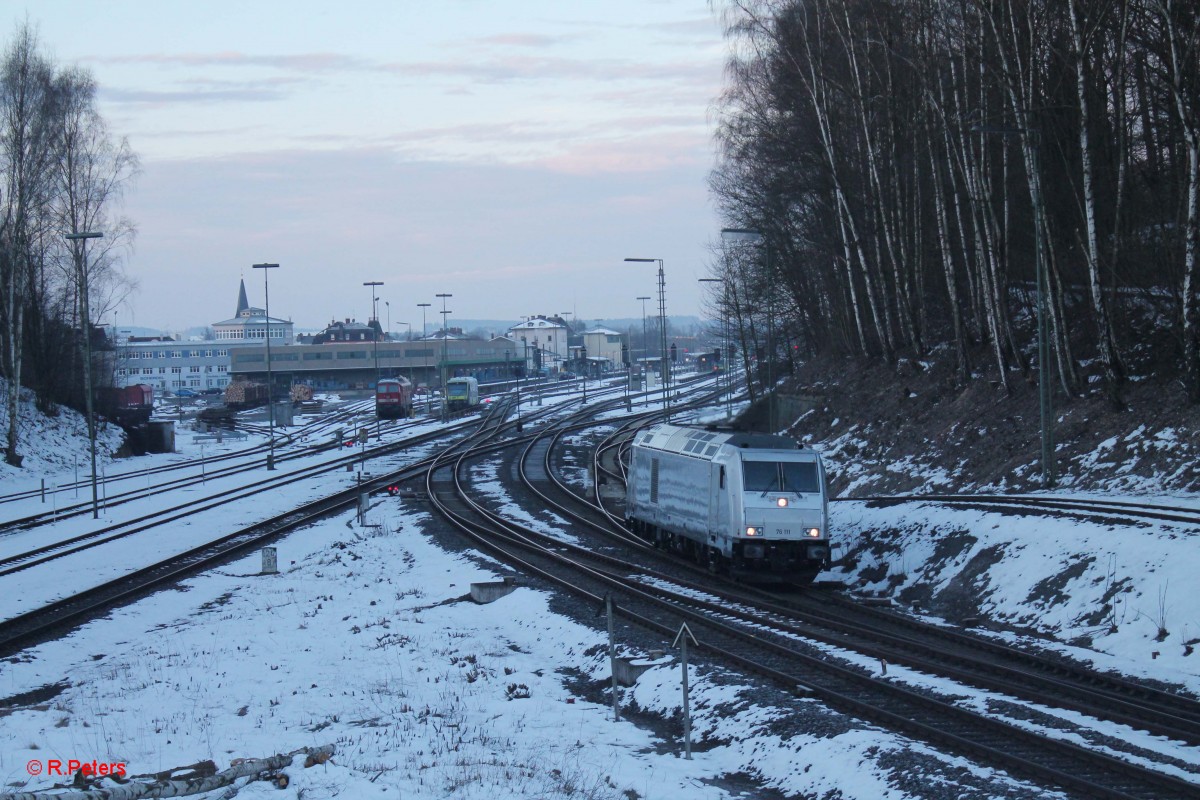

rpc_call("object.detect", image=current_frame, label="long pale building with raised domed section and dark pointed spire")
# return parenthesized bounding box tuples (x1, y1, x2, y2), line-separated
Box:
(113, 281, 294, 392)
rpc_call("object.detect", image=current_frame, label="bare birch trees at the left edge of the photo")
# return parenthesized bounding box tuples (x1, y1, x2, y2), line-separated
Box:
(0, 24, 138, 467)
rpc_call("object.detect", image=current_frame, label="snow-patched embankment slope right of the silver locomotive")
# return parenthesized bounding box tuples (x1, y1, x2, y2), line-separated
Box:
(830, 495, 1200, 693)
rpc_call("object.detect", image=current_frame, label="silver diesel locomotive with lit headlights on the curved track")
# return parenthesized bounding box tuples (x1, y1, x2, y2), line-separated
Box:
(625, 425, 829, 582)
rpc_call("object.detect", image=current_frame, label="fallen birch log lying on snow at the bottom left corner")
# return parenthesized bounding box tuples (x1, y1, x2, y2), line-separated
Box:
(0, 745, 334, 800)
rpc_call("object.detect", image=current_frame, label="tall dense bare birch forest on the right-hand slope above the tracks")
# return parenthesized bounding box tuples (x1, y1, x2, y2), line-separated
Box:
(708, 0, 1200, 404)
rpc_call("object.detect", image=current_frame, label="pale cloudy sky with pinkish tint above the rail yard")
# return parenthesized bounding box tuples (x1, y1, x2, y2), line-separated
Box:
(16, 0, 726, 332)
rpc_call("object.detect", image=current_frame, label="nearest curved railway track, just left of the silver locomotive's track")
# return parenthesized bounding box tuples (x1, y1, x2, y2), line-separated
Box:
(415, 398, 1200, 798)
